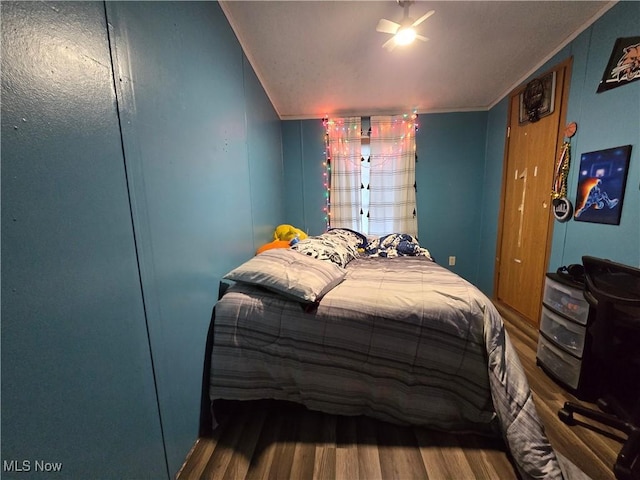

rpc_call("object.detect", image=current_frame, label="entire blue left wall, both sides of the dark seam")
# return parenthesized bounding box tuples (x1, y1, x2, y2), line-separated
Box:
(2, 2, 285, 479)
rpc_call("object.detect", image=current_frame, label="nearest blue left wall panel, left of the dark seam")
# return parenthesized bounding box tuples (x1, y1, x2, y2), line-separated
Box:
(1, 2, 168, 479)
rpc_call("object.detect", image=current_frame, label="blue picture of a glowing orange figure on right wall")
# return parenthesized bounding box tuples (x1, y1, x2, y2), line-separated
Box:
(573, 145, 631, 225)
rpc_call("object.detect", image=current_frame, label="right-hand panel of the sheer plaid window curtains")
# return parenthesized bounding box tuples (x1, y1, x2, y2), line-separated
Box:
(369, 115, 418, 237)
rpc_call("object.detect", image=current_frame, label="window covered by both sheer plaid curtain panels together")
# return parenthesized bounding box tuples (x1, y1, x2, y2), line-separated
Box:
(327, 115, 418, 236)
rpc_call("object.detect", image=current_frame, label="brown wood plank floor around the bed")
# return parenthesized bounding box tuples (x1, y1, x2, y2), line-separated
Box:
(177, 302, 624, 480)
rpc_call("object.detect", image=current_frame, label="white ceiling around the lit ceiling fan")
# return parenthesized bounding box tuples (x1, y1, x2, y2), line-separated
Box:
(220, 0, 616, 119)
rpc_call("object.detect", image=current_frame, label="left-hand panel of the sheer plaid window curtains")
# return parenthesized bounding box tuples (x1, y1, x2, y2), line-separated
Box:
(327, 117, 361, 232)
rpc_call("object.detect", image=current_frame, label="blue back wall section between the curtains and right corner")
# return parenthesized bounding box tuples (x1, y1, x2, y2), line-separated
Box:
(416, 112, 487, 283)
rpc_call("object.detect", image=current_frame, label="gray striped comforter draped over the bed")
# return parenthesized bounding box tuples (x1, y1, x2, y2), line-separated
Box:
(209, 257, 562, 479)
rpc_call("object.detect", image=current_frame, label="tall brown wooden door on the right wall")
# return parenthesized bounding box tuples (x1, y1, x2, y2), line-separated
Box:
(496, 62, 569, 325)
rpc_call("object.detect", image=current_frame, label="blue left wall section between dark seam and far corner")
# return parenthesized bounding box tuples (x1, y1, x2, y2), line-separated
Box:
(107, 2, 283, 473)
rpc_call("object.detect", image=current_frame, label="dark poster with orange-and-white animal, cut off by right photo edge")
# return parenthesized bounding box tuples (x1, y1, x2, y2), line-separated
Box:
(596, 37, 640, 93)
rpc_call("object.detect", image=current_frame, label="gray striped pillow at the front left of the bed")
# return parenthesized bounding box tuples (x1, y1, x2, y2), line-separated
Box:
(223, 248, 346, 303)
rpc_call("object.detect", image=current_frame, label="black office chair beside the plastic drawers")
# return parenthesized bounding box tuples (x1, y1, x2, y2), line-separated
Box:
(558, 256, 640, 480)
